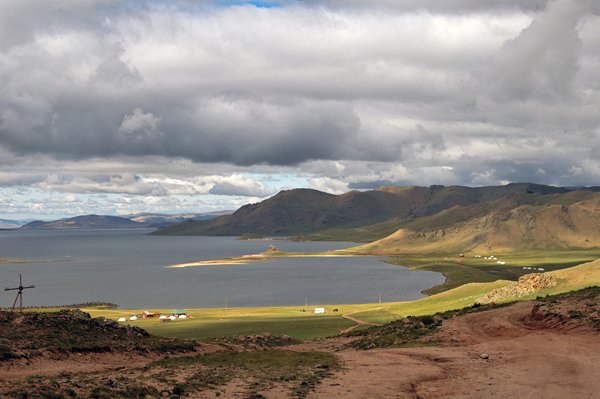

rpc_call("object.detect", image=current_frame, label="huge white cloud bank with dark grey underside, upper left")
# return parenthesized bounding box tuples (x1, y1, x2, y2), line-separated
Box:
(0, 2, 523, 165)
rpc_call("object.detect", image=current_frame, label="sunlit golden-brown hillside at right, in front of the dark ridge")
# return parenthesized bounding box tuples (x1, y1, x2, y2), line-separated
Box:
(353, 197, 600, 255)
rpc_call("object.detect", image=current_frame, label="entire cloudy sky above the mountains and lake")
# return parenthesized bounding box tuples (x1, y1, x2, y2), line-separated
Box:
(0, 0, 600, 220)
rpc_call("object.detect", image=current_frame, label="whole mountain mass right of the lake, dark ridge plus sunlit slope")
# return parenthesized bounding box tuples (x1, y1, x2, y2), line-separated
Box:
(153, 183, 600, 254)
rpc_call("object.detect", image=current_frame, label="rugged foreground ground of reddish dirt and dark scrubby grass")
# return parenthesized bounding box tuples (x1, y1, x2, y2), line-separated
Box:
(0, 288, 600, 399)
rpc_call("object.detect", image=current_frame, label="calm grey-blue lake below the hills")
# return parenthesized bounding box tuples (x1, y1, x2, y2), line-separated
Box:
(0, 229, 444, 309)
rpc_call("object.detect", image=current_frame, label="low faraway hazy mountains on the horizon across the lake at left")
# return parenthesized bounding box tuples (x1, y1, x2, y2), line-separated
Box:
(17, 211, 231, 230)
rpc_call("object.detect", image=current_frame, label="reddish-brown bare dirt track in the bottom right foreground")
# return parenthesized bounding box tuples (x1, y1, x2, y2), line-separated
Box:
(309, 302, 600, 399)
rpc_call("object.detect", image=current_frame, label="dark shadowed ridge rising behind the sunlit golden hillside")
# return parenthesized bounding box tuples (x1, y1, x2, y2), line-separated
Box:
(154, 183, 580, 239)
